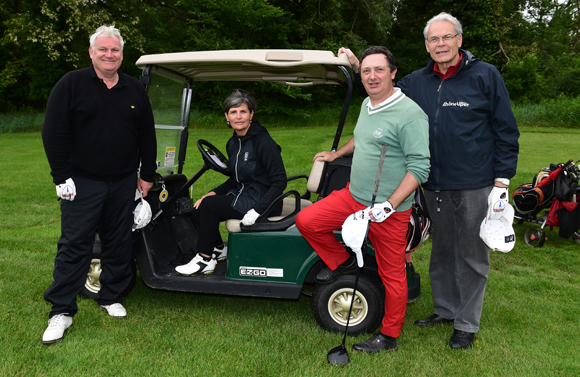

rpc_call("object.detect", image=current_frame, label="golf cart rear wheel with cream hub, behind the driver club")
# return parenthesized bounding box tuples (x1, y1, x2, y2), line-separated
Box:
(312, 275, 384, 336)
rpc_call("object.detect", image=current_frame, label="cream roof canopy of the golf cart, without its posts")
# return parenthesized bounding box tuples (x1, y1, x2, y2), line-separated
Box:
(136, 50, 352, 86)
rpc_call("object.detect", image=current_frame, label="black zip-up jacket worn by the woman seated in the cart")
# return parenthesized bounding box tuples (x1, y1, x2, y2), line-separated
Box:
(211, 121, 287, 216)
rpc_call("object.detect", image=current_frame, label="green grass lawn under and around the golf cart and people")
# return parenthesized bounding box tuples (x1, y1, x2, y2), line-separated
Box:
(0, 128, 580, 376)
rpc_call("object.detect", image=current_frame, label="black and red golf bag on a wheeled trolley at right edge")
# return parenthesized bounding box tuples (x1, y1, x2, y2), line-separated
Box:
(512, 160, 580, 247)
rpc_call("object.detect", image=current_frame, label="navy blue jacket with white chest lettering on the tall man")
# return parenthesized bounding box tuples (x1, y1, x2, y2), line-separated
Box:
(397, 50, 520, 190)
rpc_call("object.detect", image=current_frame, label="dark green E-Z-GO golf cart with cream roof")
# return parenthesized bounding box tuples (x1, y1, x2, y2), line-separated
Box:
(83, 50, 420, 335)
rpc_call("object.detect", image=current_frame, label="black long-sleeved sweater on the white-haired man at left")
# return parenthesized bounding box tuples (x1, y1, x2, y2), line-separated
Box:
(42, 66, 157, 184)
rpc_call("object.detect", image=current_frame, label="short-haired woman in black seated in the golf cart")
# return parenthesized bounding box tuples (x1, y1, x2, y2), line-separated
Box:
(175, 89, 286, 276)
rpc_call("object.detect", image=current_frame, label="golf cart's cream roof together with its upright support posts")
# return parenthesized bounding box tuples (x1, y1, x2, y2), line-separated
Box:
(136, 50, 353, 174)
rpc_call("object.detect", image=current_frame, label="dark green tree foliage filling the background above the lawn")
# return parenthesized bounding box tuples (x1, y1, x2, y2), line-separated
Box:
(0, 0, 580, 116)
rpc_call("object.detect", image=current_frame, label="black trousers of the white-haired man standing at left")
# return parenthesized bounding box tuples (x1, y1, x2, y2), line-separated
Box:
(44, 174, 137, 317)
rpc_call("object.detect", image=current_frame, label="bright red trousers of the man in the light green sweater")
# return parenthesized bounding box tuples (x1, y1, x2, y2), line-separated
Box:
(296, 186, 411, 338)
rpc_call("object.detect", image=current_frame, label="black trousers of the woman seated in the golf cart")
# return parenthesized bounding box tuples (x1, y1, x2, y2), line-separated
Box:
(191, 195, 244, 255)
